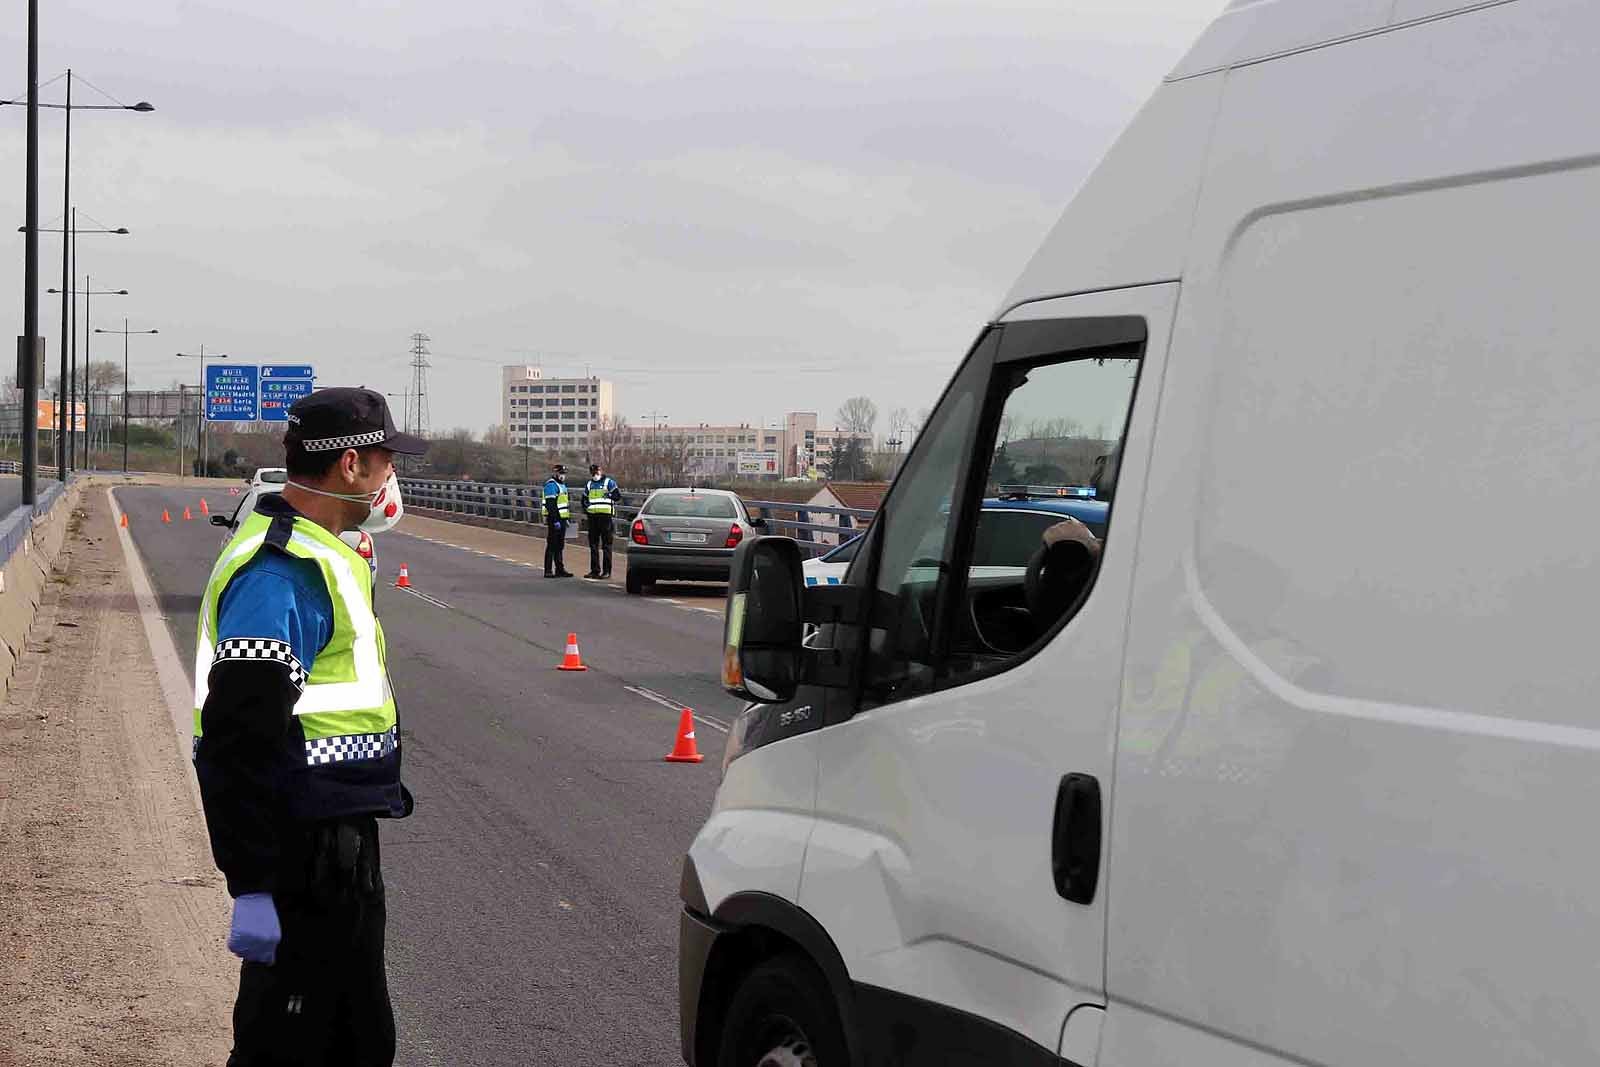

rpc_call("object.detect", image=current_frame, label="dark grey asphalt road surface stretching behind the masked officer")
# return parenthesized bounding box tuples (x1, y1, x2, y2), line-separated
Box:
(115, 488, 739, 1067)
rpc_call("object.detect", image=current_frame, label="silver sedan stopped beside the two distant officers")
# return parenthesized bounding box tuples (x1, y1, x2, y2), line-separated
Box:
(627, 490, 766, 593)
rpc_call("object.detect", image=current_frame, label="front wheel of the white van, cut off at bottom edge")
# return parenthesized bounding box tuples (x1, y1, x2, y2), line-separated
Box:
(717, 955, 848, 1067)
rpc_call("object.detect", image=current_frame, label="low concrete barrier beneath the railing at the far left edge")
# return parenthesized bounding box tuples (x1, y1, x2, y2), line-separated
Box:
(0, 478, 85, 691)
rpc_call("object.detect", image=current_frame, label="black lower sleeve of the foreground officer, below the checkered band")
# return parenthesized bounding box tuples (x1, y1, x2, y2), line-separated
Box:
(195, 659, 299, 897)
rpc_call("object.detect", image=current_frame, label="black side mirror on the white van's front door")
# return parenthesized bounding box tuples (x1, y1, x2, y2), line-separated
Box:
(722, 536, 805, 704)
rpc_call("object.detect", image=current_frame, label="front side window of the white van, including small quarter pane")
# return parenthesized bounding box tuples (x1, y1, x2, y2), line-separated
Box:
(861, 337, 1139, 707)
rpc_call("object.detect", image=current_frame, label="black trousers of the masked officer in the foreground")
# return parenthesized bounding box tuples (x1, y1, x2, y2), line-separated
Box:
(227, 817, 395, 1067)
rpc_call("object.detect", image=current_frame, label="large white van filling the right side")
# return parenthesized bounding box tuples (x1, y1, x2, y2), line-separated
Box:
(680, 0, 1600, 1067)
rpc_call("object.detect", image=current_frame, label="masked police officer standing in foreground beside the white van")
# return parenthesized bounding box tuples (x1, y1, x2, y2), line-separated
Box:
(194, 389, 427, 1067)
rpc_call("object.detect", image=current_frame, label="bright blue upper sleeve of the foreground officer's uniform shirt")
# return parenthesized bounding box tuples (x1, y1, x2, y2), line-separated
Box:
(216, 547, 333, 675)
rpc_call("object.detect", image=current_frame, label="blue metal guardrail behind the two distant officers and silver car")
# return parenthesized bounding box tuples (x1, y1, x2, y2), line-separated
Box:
(400, 478, 874, 555)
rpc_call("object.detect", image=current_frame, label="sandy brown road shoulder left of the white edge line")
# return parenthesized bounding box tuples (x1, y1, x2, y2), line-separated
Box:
(0, 490, 237, 1067)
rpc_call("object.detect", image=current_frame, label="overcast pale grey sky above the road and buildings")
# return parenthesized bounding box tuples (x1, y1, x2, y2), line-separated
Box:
(0, 0, 1221, 432)
